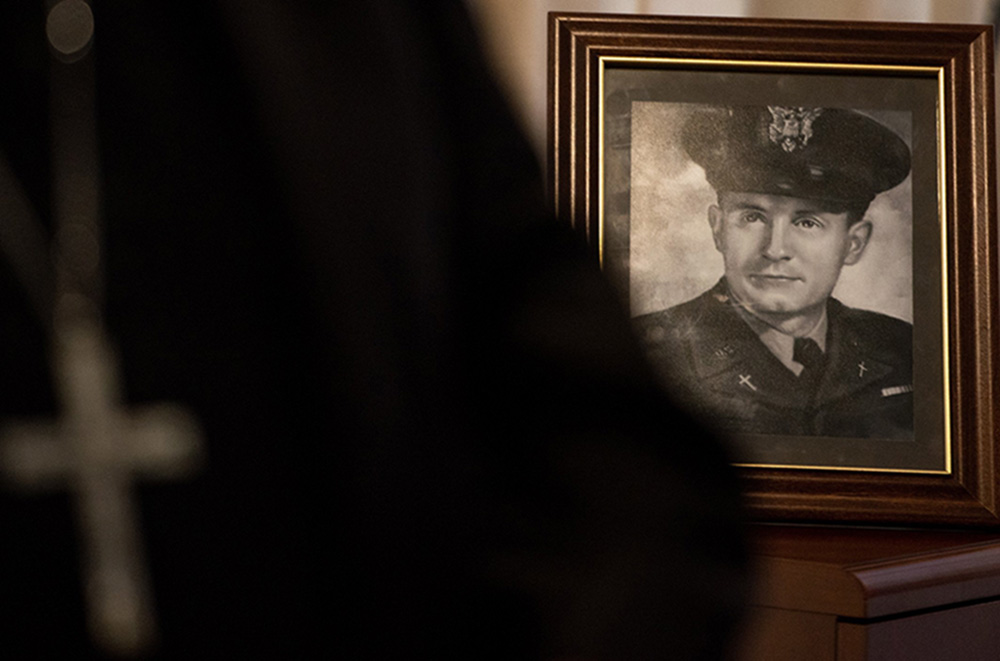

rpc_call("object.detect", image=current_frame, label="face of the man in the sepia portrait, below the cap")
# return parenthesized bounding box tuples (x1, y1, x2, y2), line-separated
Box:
(709, 192, 871, 320)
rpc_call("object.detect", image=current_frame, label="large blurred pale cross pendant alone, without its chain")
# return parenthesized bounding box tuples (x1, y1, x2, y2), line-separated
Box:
(0, 323, 207, 656)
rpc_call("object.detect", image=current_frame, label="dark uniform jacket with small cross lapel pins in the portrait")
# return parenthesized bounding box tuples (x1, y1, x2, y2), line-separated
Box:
(636, 279, 913, 438)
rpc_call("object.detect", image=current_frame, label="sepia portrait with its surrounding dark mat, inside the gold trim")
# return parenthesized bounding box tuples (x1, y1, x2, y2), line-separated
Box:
(601, 64, 947, 470)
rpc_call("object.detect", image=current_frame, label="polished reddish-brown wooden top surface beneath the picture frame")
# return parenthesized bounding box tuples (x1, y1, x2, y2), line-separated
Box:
(751, 525, 1000, 618)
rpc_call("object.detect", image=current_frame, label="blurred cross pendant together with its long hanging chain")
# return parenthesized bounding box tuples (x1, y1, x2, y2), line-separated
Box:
(0, 0, 201, 656)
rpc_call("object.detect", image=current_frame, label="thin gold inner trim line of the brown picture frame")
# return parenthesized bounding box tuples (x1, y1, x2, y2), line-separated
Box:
(597, 55, 953, 475)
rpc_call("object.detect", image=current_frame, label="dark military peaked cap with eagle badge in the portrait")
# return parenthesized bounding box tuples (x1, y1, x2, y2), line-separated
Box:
(683, 106, 910, 207)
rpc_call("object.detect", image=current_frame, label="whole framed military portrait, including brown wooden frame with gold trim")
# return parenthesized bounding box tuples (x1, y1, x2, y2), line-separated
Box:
(549, 13, 1000, 526)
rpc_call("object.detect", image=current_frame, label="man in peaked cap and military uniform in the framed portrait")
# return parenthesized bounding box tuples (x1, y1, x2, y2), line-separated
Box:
(636, 106, 913, 438)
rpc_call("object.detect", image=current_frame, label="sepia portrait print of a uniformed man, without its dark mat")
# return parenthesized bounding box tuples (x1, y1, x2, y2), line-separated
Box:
(630, 103, 913, 440)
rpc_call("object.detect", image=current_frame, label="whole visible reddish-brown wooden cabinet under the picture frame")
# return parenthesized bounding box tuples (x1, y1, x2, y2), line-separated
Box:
(738, 526, 1000, 661)
